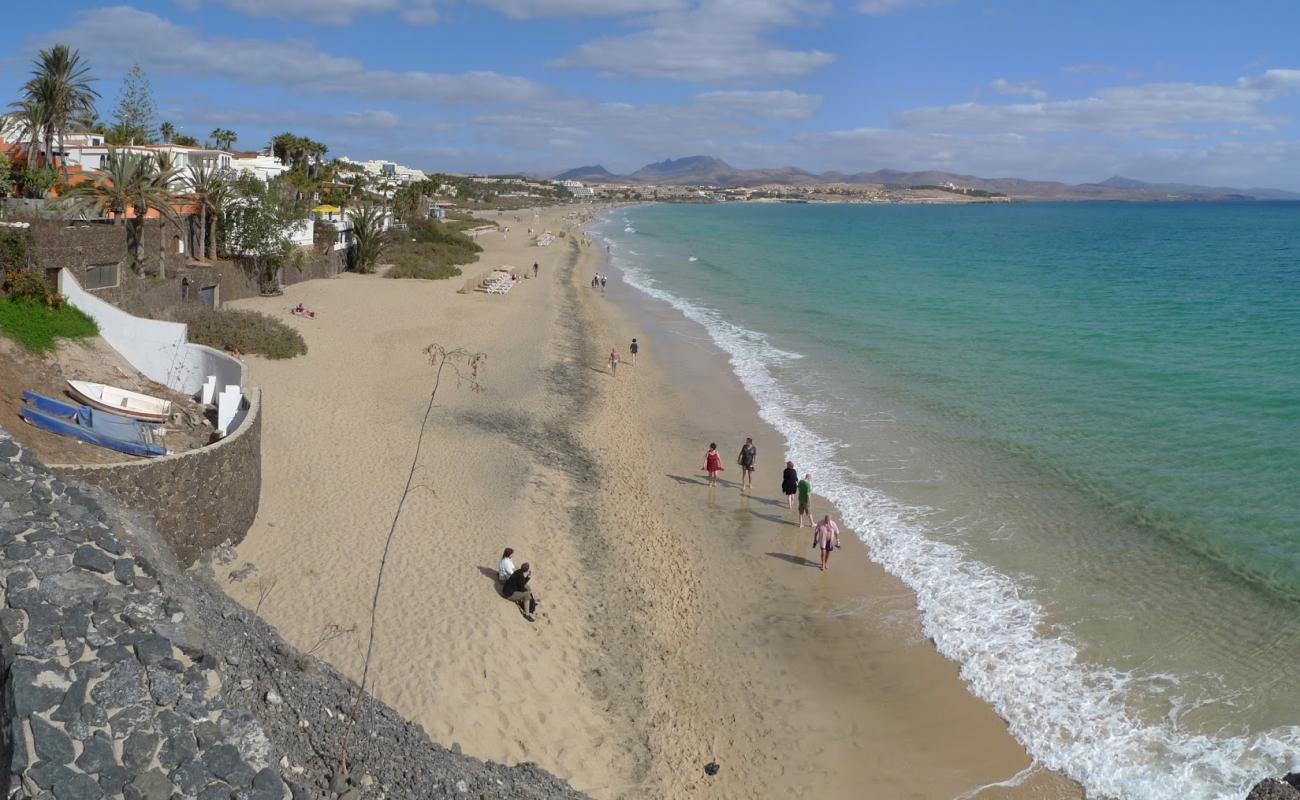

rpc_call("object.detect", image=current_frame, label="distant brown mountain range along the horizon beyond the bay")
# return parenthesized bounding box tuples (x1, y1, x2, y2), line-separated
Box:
(553, 156, 1300, 200)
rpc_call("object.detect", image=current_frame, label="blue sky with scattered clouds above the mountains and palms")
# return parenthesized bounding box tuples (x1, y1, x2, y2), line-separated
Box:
(0, 0, 1300, 191)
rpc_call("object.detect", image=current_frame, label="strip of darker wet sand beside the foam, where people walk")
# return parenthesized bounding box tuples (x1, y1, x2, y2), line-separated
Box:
(579, 218, 1082, 799)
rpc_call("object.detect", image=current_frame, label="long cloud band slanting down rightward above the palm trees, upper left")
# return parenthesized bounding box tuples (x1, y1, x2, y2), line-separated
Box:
(46, 5, 549, 105)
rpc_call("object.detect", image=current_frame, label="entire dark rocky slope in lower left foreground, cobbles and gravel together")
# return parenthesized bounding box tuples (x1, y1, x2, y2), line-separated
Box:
(0, 431, 582, 800)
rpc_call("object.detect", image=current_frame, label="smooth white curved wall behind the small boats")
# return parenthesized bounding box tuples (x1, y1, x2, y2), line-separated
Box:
(59, 269, 244, 394)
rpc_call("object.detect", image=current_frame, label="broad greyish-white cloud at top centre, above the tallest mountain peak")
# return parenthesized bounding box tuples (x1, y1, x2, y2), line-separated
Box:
(553, 0, 835, 83)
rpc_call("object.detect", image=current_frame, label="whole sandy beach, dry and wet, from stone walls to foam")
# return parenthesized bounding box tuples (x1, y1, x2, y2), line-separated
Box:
(218, 208, 1074, 797)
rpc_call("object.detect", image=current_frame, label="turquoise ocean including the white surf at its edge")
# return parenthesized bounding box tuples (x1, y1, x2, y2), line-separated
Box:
(590, 203, 1300, 800)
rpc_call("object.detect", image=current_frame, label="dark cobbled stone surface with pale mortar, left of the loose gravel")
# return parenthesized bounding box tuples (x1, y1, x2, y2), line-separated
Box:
(0, 431, 291, 800)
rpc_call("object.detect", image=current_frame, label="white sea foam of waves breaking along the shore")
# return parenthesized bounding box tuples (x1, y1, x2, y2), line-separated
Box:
(595, 221, 1300, 800)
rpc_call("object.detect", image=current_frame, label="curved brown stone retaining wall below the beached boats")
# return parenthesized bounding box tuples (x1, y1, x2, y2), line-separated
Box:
(51, 389, 261, 566)
